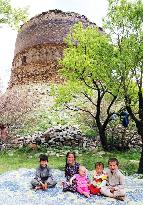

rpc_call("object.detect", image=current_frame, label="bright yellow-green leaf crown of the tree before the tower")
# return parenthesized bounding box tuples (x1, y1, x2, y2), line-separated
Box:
(61, 23, 117, 89)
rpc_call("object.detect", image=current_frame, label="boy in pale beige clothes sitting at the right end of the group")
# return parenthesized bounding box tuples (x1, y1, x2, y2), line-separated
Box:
(101, 158, 125, 201)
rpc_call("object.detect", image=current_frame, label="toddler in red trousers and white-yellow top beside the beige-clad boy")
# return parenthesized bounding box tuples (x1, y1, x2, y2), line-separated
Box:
(89, 162, 107, 195)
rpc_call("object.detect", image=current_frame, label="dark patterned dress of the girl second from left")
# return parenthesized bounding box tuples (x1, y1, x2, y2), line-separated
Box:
(63, 162, 80, 192)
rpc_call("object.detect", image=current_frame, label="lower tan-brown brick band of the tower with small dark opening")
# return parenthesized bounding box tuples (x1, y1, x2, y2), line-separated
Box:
(10, 44, 64, 87)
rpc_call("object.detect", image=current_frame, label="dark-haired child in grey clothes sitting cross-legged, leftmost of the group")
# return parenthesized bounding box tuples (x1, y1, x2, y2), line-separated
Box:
(31, 154, 57, 190)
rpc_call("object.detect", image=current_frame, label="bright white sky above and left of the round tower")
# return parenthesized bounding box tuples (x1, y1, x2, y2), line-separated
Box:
(0, 0, 108, 92)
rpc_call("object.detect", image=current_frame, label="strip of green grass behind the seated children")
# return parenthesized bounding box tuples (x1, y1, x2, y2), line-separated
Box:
(0, 147, 140, 175)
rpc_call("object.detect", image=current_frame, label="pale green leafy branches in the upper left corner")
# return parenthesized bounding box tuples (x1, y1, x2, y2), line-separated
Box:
(0, 0, 28, 29)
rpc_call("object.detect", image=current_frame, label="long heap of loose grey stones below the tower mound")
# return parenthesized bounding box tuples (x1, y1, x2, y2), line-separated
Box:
(5, 126, 99, 150)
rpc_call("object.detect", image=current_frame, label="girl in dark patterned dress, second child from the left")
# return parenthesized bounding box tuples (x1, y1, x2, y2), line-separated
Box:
(62, 152, 79, 192)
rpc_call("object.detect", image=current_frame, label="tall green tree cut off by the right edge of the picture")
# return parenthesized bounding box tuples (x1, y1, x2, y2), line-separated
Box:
(105, 0, 143, 173)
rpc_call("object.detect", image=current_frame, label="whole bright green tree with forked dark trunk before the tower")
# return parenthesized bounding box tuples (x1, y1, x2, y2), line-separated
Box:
(57, 23, 120, 150)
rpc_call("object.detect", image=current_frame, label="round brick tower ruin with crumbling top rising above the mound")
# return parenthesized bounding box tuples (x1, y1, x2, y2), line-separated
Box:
(9, 10, 98, 87)
